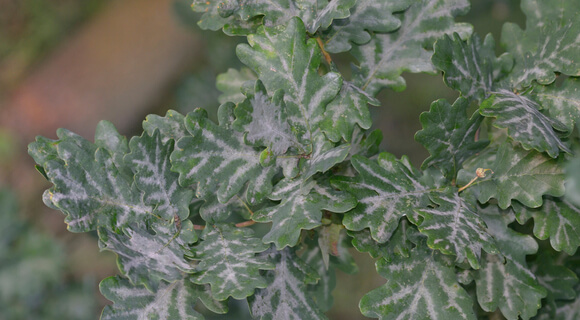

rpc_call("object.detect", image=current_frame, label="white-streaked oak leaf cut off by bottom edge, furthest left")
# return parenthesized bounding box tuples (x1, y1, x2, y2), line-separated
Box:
(99, 276, 227, 320)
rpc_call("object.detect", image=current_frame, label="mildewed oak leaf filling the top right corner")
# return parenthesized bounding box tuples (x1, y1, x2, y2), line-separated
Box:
(501, 0, 580, 89)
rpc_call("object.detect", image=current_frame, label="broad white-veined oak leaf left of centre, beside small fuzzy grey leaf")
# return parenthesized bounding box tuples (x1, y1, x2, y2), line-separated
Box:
(171, 104, 278, 203)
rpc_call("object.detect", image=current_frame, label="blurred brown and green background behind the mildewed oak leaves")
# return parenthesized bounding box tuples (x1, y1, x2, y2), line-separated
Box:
(0, 0, 524, 320)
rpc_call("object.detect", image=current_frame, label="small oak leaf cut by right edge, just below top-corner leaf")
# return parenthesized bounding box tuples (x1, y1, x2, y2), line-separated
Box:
(533, 78, 580, 132)
